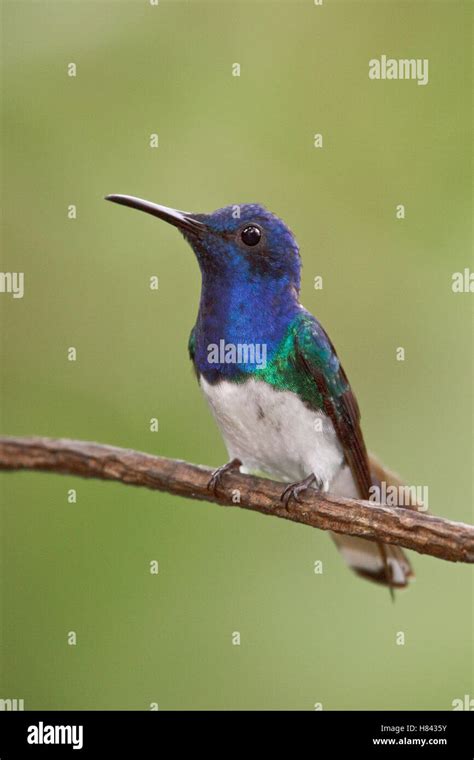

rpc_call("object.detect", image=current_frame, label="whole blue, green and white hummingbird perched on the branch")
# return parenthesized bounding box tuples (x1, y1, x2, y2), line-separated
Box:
(106, 195, 413, 597)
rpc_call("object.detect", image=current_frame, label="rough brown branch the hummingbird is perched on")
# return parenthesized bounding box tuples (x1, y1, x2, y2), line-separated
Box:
(0, 437, 474, 563)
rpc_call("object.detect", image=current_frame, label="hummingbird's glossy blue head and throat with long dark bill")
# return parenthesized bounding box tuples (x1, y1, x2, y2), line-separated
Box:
(104, 195, 301, 371)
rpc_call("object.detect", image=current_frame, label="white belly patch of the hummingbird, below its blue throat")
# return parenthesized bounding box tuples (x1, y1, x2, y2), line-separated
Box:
(200, 377, 344, 490)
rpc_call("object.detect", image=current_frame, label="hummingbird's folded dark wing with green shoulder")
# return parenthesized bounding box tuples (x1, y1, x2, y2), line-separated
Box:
(295, 317, 372, 499)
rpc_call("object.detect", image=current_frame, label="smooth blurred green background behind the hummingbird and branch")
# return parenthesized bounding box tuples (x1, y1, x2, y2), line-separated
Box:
(0, 0, 473, 710)
